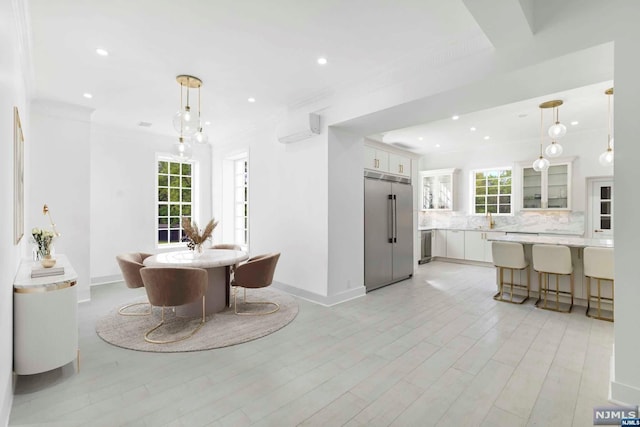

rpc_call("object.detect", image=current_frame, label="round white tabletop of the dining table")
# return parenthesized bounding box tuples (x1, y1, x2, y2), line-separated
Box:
(143, 249, 249, 268)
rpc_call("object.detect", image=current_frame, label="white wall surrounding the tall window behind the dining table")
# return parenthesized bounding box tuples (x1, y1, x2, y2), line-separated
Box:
(89, 125, 211, 283)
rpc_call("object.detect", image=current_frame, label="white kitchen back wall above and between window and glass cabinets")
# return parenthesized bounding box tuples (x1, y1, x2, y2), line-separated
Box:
(419, 126, 613, 214)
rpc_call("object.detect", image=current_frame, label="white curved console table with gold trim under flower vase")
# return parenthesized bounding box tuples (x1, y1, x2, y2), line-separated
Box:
(13, 255, 79, 375)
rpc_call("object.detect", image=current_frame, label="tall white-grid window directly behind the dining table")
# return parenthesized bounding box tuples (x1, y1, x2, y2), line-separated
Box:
(156, 156, 195, 246)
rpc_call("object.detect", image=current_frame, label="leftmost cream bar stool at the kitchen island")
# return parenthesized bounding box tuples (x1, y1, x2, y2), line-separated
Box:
(491, 242, 530, 304)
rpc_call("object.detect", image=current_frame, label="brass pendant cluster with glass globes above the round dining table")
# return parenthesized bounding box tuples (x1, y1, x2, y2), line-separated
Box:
(173, 74, 208, 159)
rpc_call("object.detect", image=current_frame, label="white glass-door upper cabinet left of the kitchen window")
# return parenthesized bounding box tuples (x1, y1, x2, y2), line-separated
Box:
(420, 169, 456, 210)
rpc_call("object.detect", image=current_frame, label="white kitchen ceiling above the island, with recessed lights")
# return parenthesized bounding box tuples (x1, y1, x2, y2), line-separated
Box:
(369, 81, 613, 154)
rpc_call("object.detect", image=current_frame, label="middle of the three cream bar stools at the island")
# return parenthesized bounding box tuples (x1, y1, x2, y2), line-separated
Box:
(532, 244, 574, 313)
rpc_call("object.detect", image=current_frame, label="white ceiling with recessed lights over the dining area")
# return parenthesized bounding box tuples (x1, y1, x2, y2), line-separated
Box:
(28, 0, 490, 141)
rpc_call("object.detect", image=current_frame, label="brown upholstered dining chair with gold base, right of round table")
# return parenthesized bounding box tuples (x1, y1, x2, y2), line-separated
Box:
(231, 253, 280, 315)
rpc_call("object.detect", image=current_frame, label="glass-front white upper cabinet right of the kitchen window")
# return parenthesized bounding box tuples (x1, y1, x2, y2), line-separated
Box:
(522, 160, 573, 210)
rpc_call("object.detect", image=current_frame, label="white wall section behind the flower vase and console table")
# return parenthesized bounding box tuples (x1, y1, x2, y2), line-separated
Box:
(25, 100, 92, 301)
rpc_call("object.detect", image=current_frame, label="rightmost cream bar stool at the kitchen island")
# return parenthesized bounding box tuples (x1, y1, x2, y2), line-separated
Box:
(583, 247, 613, 322)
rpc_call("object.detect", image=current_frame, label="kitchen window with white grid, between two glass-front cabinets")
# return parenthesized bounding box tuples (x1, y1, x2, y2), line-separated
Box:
(471, 168, 513, 214)
